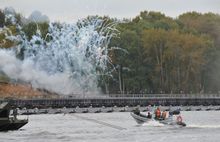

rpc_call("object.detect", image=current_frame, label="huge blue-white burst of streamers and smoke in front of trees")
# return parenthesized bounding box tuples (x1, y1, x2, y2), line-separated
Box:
(0, 18, 116, 95)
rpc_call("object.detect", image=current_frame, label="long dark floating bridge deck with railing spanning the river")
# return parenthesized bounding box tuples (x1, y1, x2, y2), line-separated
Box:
(1, 94, 220, 108)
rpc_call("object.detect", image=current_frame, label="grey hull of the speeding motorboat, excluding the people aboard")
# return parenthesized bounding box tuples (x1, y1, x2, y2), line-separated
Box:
(130, 112, 186, 126)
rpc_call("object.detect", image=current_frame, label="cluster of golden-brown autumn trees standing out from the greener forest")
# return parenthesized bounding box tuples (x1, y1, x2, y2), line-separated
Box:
(142, 29, 211, 93)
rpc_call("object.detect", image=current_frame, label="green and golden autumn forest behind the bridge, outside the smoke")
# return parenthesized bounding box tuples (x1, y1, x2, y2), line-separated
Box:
(0, 10, 220, 96)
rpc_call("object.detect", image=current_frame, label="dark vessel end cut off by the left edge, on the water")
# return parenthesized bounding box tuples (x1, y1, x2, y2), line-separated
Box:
(0, 102, 28, 131)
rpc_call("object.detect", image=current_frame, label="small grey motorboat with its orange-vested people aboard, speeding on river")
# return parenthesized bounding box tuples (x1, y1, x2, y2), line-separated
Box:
(130, 109, 186, 127)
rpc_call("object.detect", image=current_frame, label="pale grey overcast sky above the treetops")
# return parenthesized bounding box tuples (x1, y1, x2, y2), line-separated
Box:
(0, 0, 220, 22)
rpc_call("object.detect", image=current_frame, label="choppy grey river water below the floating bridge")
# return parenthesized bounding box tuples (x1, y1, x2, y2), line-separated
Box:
(0, 111, 220, 142)
